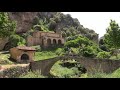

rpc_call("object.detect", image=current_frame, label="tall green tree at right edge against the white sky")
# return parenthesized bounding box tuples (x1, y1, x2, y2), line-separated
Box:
(104, 20, 120, 57)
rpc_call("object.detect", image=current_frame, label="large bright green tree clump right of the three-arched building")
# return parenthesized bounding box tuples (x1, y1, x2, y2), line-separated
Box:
(64, 36, 102, 57)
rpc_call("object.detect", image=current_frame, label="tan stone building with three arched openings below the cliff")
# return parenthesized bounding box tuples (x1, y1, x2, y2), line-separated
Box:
(27, 31, 65, 48)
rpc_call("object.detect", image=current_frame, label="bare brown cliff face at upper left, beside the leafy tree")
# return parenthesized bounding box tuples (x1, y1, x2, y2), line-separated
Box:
(8, 12, 38, 33)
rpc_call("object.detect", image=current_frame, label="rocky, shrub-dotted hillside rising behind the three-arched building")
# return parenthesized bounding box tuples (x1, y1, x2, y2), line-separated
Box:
(8, 12, 98, 42)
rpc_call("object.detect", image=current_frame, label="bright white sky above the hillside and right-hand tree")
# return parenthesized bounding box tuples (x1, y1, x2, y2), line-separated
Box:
(62, 12, 120, 38)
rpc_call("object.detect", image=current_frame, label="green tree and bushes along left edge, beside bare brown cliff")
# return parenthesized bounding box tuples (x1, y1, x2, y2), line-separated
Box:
(0, 12, 26, 50)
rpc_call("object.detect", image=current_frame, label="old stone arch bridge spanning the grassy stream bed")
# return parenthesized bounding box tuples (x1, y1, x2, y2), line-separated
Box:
(30, 56, 120, 75)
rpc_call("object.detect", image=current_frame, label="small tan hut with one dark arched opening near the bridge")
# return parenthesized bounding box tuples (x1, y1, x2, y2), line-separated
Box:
(10, 46, 36, 63)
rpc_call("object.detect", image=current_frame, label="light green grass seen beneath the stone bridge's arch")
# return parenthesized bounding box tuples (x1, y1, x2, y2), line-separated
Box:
(50, 61, 81, 78)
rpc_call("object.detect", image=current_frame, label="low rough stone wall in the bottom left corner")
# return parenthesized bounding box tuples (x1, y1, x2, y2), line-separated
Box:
(0, 65, 29, 78)
